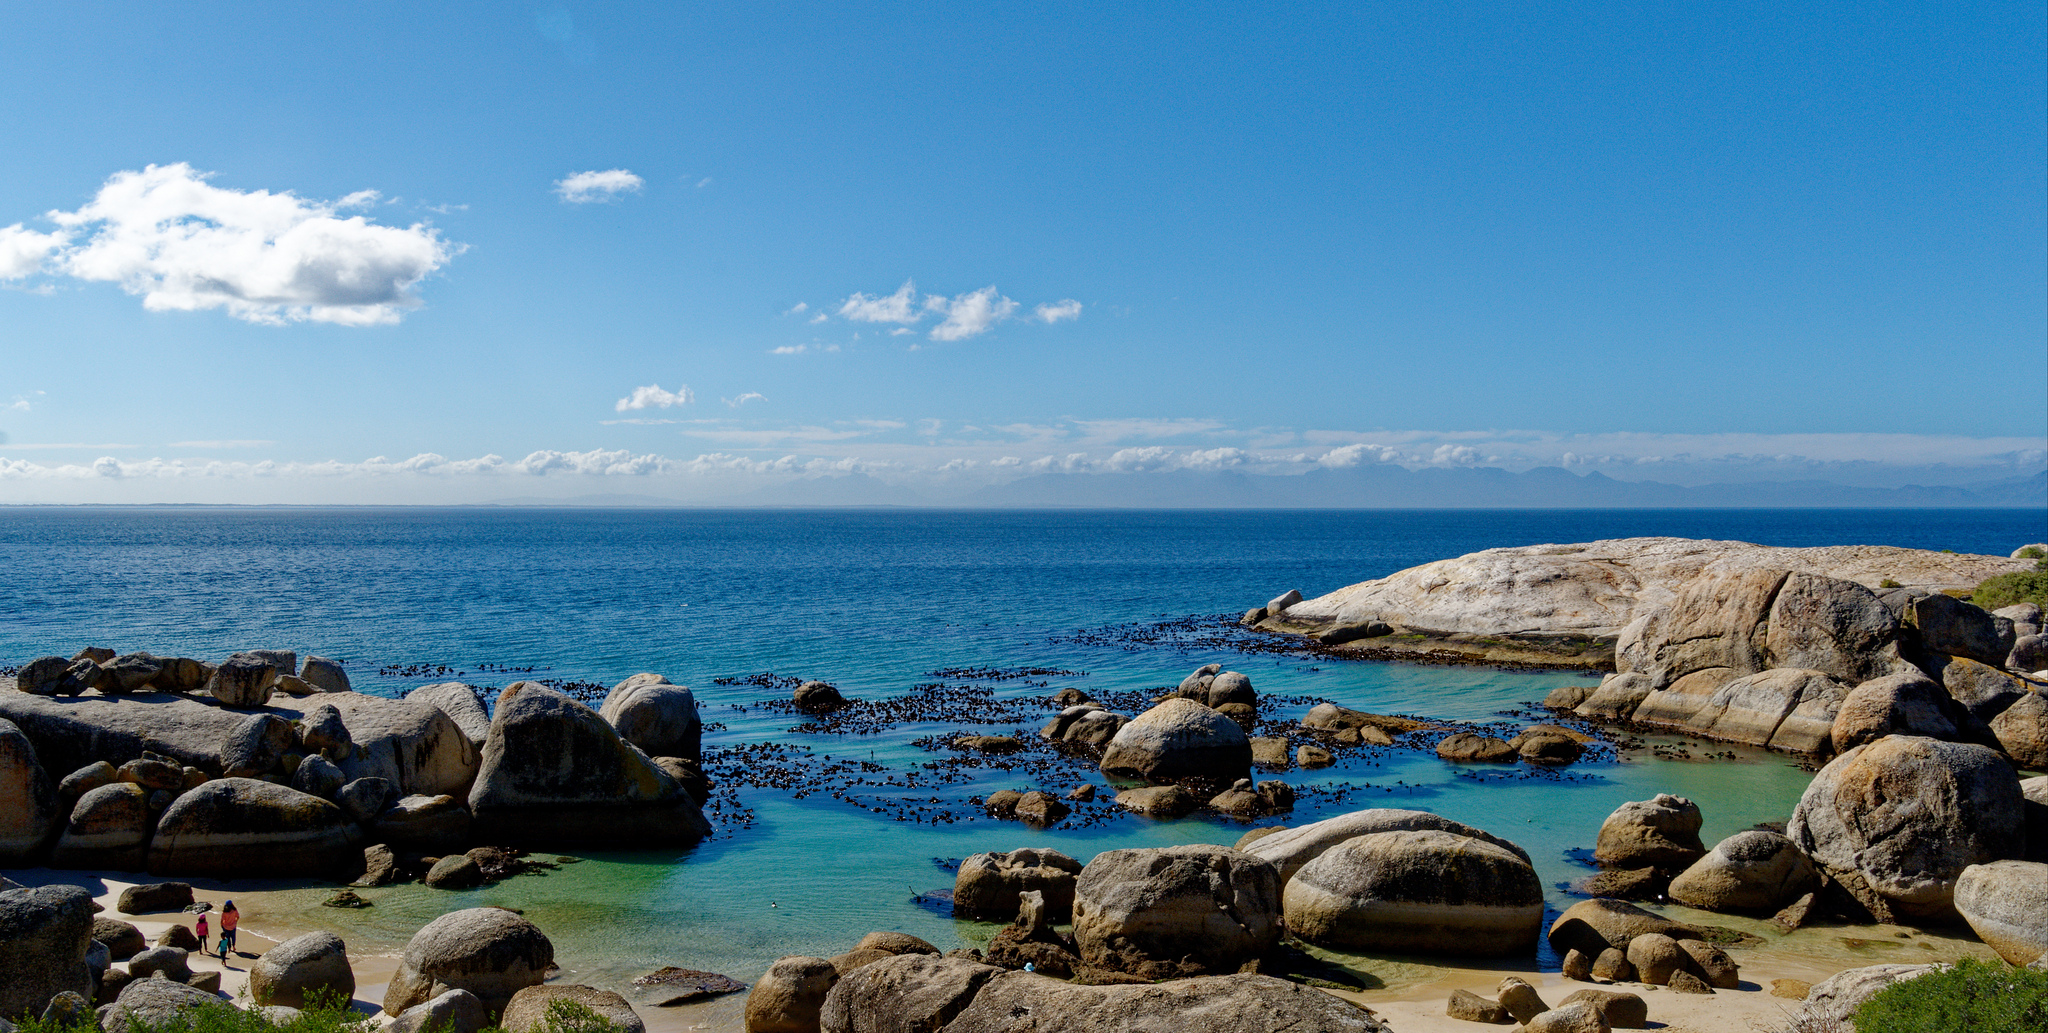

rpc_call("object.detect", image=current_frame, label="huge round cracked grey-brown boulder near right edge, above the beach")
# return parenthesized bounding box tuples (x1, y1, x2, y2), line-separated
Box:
(1786, 736, 2025, 922)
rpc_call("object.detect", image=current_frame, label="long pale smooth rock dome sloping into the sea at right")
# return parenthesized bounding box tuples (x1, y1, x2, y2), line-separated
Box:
(1262, 537, 2032, 647)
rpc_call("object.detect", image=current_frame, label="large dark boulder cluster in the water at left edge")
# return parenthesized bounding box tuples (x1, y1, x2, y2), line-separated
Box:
(0, 650, 709, 885)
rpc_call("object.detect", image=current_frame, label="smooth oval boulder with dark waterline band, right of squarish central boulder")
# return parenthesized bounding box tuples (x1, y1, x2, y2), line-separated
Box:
(1282, 830, 1542, 957)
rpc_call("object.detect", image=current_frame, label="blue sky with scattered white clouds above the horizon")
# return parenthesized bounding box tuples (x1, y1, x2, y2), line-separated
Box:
(0, 2, 2048, 502)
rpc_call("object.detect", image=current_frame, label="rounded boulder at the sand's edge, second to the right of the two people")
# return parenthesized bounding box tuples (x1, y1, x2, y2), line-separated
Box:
(383, 908, 555, 1015)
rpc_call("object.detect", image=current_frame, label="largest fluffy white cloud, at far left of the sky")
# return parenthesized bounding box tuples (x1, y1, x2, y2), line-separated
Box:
(19, 162, 463, 326)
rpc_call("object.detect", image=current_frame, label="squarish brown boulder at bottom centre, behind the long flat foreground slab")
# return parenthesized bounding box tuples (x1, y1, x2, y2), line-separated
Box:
(1073, 844, 1280, 980)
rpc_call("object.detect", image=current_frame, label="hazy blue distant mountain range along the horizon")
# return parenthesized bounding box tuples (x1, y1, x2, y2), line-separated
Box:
(494, 463, 2048, 510)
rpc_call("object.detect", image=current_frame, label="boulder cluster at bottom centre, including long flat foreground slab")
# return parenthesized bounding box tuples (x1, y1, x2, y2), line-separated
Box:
(745, 846, 1386, 1033)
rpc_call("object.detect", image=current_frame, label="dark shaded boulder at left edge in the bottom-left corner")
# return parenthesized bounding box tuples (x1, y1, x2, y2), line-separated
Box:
(0, 885, 94, 1021)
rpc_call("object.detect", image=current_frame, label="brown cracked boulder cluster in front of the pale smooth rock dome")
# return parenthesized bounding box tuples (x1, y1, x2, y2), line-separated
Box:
(1544, 572, 2048, 769)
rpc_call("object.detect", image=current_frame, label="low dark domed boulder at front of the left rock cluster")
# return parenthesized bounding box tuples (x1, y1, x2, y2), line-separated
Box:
(150, 779, 362, 881)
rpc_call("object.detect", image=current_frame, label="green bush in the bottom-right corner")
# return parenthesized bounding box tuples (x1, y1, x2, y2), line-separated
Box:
(1855, 957, 2048, 1033)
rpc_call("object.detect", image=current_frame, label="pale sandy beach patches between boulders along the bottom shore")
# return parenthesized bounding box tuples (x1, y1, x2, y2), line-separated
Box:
(28, 869, 1995, 1033)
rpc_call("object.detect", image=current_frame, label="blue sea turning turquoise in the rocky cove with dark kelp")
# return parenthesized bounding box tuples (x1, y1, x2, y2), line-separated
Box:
(0, 508, 2048, 996)
